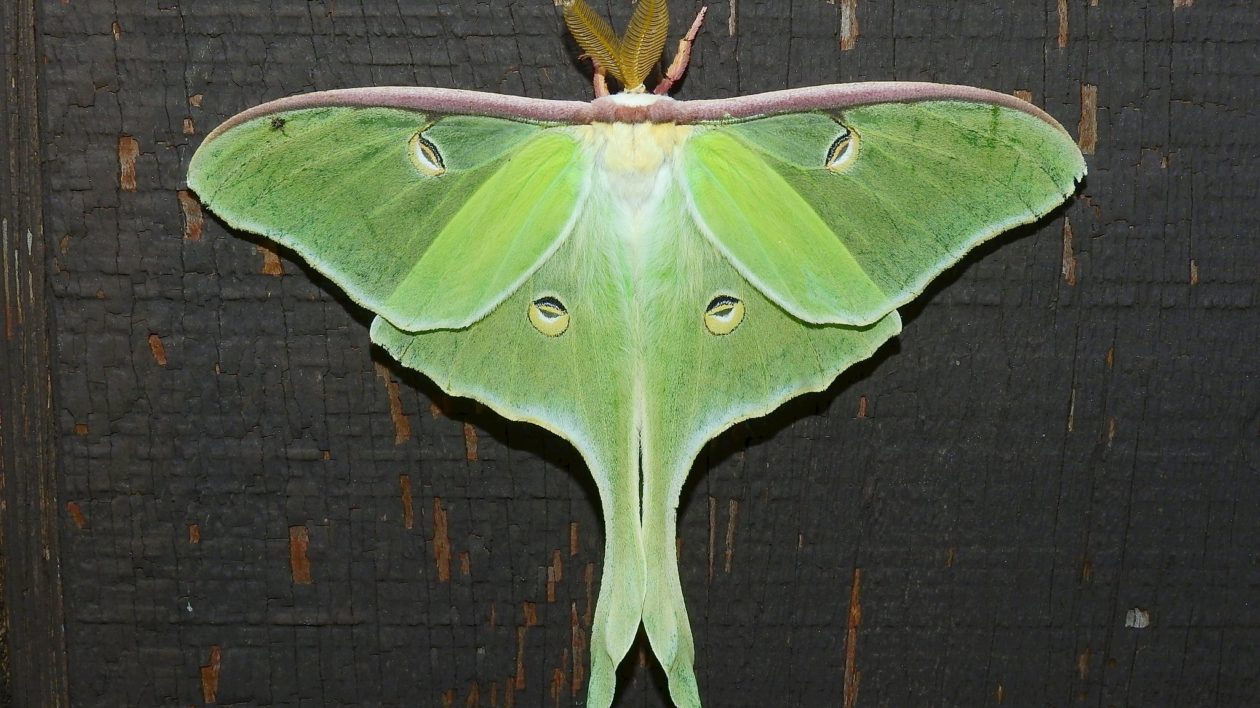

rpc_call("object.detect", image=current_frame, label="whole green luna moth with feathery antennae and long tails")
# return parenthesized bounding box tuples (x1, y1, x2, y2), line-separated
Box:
(188, 0, 1085, 707)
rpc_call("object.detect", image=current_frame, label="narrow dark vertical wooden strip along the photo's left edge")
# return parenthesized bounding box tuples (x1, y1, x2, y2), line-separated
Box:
(0, 0, 70, 707)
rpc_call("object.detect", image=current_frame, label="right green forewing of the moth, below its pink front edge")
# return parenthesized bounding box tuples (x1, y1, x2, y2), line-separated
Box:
(684, 100, 1085, 324)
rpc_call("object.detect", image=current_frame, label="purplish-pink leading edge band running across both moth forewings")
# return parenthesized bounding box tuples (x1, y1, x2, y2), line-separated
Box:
(205, 81, 1067, 141)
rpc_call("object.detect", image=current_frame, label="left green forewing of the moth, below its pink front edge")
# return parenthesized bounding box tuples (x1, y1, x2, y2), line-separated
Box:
(188, 99, 588, 330)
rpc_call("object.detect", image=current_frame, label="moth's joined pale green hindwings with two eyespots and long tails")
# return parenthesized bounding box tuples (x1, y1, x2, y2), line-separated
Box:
(372, 182, 901, 705)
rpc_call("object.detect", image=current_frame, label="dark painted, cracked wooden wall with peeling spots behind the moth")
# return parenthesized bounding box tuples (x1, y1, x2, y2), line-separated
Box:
(0, 0, 1260, 707)
